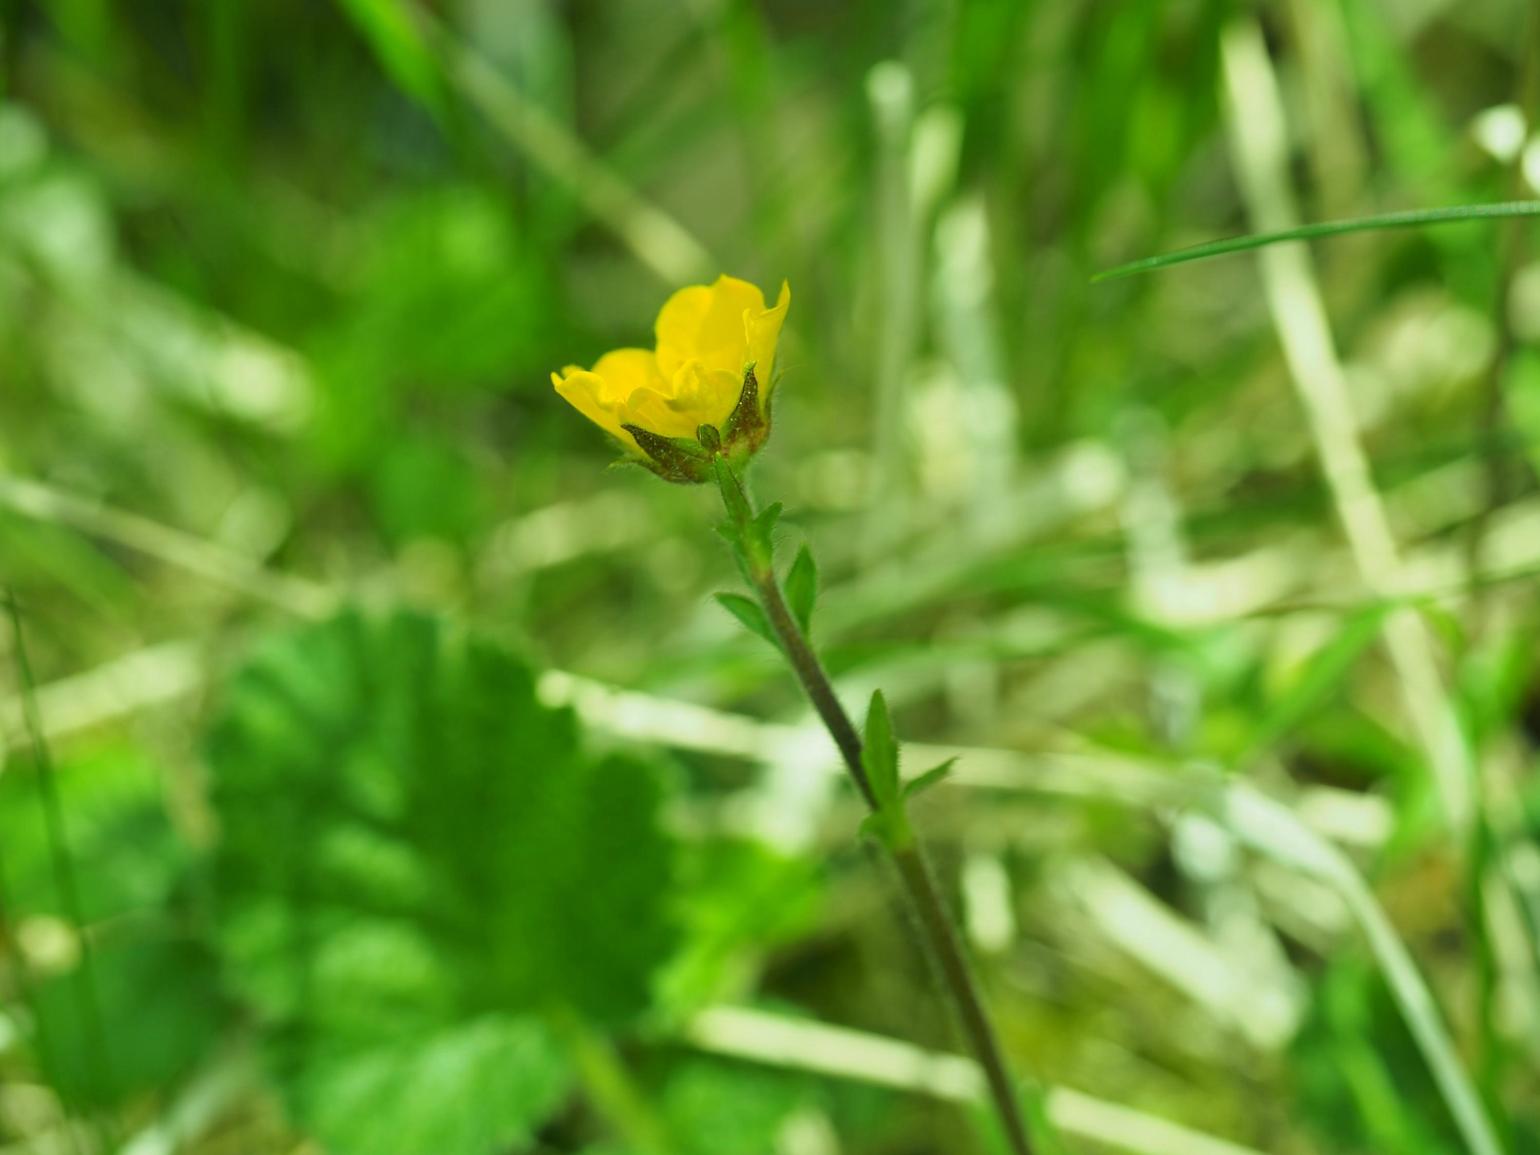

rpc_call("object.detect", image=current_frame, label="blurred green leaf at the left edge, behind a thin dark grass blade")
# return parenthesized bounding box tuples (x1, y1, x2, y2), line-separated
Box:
(0, 747, 228, 1109)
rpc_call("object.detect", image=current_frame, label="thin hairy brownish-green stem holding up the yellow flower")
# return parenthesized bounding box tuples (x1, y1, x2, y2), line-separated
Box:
(718, 468, 1032, 1155)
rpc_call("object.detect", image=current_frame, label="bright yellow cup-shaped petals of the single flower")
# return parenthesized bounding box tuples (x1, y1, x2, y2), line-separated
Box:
(551, 276, 792, 456)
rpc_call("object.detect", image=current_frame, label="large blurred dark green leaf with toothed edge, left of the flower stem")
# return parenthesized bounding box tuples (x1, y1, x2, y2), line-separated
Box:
(208, 613, 675, 1155)
